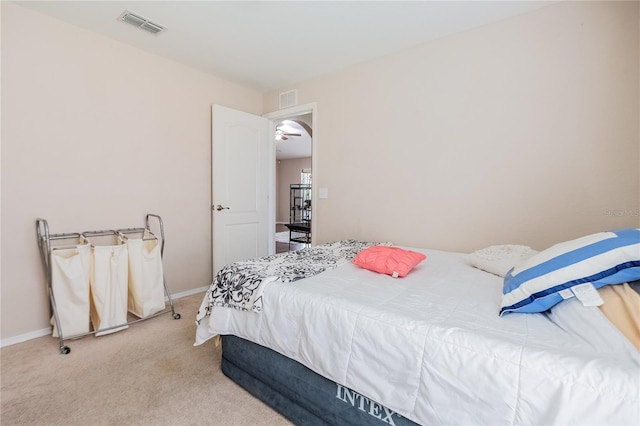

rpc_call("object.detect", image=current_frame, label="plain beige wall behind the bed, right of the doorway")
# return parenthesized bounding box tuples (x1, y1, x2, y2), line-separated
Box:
(264, 2, 640, 251)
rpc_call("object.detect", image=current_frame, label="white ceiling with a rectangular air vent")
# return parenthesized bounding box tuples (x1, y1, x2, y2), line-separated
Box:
(16, 0, 554, 92)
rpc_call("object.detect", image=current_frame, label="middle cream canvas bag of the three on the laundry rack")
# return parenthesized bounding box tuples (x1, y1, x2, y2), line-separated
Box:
(91, 244, 129, 336)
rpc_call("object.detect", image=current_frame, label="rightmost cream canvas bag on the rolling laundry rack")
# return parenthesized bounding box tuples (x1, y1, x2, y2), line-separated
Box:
(127, 230, 165, 318)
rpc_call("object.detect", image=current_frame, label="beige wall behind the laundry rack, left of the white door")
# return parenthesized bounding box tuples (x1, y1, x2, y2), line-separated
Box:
(1, 2, 262, 340)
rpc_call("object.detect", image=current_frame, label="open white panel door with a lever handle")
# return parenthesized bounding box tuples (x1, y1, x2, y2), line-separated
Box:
(211, 105, 273, 274)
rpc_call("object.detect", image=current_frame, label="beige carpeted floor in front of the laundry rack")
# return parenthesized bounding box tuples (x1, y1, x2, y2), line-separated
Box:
(0, 294, 290, 426)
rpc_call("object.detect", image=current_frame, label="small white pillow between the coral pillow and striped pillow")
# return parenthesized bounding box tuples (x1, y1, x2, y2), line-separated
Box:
(467, 244, 538, 277)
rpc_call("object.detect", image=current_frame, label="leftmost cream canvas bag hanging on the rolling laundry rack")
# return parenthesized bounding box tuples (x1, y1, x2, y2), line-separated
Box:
(51, 244, 91, 337)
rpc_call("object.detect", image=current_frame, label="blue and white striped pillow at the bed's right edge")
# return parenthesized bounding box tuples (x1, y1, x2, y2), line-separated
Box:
(500, 228, 640, 315)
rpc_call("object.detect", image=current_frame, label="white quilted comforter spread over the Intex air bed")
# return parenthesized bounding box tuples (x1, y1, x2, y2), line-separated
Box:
(196, 249, 640, 425)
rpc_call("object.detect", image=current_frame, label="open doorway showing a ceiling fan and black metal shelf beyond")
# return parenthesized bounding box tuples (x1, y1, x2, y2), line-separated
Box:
(265, 104, 317, 253)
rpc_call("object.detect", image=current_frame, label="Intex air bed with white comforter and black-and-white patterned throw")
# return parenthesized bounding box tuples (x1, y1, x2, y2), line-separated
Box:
(195, 236, 640, 425)
